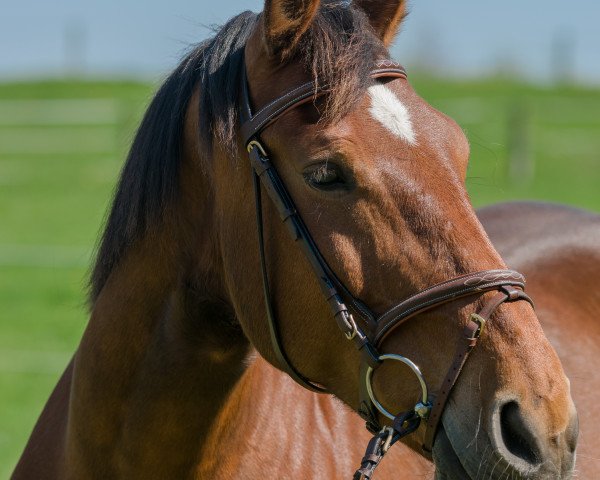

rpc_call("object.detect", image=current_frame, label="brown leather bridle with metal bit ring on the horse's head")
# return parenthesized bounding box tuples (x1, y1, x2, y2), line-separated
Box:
(240, 56, 533, 480)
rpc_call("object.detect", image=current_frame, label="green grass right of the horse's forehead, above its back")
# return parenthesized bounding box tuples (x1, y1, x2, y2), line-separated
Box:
(413, 78, 600, 211)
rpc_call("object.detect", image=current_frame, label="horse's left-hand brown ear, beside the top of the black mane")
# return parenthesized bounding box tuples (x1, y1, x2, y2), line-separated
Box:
(263, 0, 321, 58)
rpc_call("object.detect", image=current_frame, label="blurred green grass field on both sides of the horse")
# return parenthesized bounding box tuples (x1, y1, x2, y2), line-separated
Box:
(0, 77, 600, 478)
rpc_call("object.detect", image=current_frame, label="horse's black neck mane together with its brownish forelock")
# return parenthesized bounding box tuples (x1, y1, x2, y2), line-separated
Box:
(90, 1, 386, 302)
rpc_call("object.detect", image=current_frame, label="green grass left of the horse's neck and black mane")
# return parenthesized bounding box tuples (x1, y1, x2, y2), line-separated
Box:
(0, 81, 153, 478)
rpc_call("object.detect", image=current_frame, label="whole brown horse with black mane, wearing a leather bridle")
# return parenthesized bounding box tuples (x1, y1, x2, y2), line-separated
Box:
(13, 0, 598, 480)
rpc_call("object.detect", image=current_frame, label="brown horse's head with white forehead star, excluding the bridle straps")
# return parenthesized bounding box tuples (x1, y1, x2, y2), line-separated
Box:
(200, 0, 577, 479)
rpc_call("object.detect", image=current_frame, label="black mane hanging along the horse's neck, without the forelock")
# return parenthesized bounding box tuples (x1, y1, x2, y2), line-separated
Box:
(90, 12, 256, 302)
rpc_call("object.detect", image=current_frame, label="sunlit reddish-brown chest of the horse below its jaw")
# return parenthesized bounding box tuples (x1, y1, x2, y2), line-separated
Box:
(199, 355, 431, 480)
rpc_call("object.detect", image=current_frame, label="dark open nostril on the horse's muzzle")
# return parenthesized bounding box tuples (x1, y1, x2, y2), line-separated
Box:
(500, 401, 540, 465)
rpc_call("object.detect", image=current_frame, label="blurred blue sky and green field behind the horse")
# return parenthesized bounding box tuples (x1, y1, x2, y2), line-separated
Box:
(0, 0, 600, 472)
